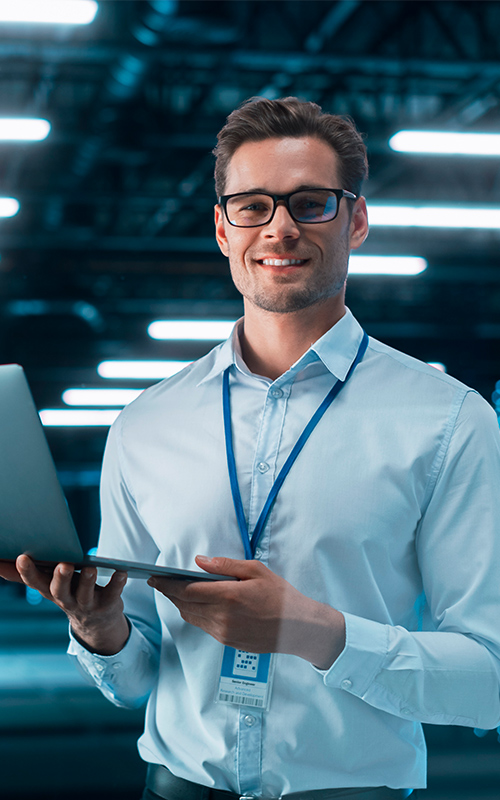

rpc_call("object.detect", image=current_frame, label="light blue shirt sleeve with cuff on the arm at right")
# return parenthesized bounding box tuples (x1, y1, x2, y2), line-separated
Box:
(323, 391, 500, 729)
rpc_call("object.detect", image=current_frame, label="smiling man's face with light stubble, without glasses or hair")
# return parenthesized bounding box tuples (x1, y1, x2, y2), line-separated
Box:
(215, 137, 368, 313)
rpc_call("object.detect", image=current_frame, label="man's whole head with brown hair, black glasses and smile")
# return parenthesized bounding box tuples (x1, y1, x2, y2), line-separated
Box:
(215, 98, 368, 318)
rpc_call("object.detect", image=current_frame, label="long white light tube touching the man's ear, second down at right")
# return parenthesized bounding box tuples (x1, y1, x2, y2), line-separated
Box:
(368, 203, 500, 230)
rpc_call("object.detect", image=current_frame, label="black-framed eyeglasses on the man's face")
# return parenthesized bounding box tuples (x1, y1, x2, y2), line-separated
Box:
(219, 189, 358, 228)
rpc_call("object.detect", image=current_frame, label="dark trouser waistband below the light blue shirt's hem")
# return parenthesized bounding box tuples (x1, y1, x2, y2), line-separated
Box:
(146, 764, 413, 800)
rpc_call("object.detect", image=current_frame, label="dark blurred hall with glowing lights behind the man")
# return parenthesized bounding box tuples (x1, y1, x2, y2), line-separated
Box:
(0, 0, 500, 800)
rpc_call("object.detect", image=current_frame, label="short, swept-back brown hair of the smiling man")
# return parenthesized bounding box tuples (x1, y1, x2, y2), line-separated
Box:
(213, 97, 368, 197)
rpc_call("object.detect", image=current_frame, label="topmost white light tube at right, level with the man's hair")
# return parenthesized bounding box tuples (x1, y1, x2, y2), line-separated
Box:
(389, 131, 500, 156)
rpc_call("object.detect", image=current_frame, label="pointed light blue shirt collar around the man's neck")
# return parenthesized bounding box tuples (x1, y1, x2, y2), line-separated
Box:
(198, 309, 363, 385)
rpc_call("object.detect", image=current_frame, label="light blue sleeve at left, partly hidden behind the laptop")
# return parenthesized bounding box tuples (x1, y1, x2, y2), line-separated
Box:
(68, 412, 161, 708)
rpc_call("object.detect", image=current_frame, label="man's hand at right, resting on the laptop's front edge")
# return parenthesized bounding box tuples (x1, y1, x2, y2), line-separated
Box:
(148, 556, 345, 669)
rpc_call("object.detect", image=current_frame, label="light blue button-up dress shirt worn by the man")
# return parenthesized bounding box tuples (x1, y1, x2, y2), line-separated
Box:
(70, 312, 500, 797)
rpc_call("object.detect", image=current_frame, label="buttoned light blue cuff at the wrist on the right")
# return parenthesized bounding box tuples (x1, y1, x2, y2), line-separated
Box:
(314, 612, 389, 697)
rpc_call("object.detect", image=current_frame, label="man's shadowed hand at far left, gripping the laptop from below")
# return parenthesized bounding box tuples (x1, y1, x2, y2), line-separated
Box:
(0, 555, 129, 656)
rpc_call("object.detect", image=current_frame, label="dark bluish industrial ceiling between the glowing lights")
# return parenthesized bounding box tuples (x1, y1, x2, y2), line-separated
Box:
(0, 0, 500, 476)
